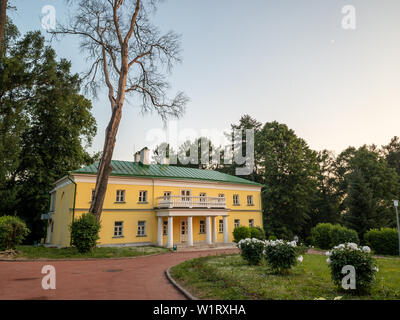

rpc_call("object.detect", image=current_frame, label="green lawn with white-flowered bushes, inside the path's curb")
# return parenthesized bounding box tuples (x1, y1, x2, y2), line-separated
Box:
(171, 254, 400, 300)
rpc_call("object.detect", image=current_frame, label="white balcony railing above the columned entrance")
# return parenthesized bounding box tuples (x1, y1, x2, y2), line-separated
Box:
(157, 196, 226, 209)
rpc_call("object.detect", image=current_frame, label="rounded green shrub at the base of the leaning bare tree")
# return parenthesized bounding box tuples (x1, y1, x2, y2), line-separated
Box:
(70, 213, 100, 253)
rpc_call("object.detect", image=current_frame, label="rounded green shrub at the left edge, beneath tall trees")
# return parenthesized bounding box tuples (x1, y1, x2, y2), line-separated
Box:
(0, 216, 29, 250)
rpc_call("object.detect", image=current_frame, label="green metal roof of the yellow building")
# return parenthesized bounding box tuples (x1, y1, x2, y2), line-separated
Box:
(73, 160, 262, 186)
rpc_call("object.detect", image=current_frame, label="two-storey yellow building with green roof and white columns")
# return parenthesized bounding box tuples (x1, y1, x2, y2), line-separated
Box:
(42, 148, 262, 248)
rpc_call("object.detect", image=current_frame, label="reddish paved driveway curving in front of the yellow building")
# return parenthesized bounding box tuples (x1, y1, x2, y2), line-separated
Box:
(0, 249, 238, 300)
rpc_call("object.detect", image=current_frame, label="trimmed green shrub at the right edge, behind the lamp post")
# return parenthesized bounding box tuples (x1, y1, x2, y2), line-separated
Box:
(364, 228, 399, 255)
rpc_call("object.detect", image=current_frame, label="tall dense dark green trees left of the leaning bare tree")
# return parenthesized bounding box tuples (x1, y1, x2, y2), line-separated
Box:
(0, 26, 96, 242)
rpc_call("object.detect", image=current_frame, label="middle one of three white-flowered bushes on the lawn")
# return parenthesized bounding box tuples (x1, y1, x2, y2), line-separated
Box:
(265, 240, 303, 273)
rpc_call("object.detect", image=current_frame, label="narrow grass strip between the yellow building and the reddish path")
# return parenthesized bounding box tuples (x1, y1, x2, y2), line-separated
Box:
(10, 246, 169, 259)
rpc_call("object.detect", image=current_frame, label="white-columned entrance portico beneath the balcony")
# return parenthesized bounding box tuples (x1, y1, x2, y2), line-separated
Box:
(157, 209, 229, 248)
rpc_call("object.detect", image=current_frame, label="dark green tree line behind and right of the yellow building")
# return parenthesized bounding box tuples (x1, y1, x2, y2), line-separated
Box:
(153, 115, 400, 240)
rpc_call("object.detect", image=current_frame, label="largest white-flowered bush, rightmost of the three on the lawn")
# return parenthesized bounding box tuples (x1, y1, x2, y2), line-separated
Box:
(326, 242, 379, 292)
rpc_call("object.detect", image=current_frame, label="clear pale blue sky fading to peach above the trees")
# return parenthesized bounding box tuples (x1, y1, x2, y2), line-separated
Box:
(11, 0, 400, 160)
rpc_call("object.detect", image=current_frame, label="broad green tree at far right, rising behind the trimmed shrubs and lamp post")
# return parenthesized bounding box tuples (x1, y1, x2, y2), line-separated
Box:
(336, 146, 400, 241)
